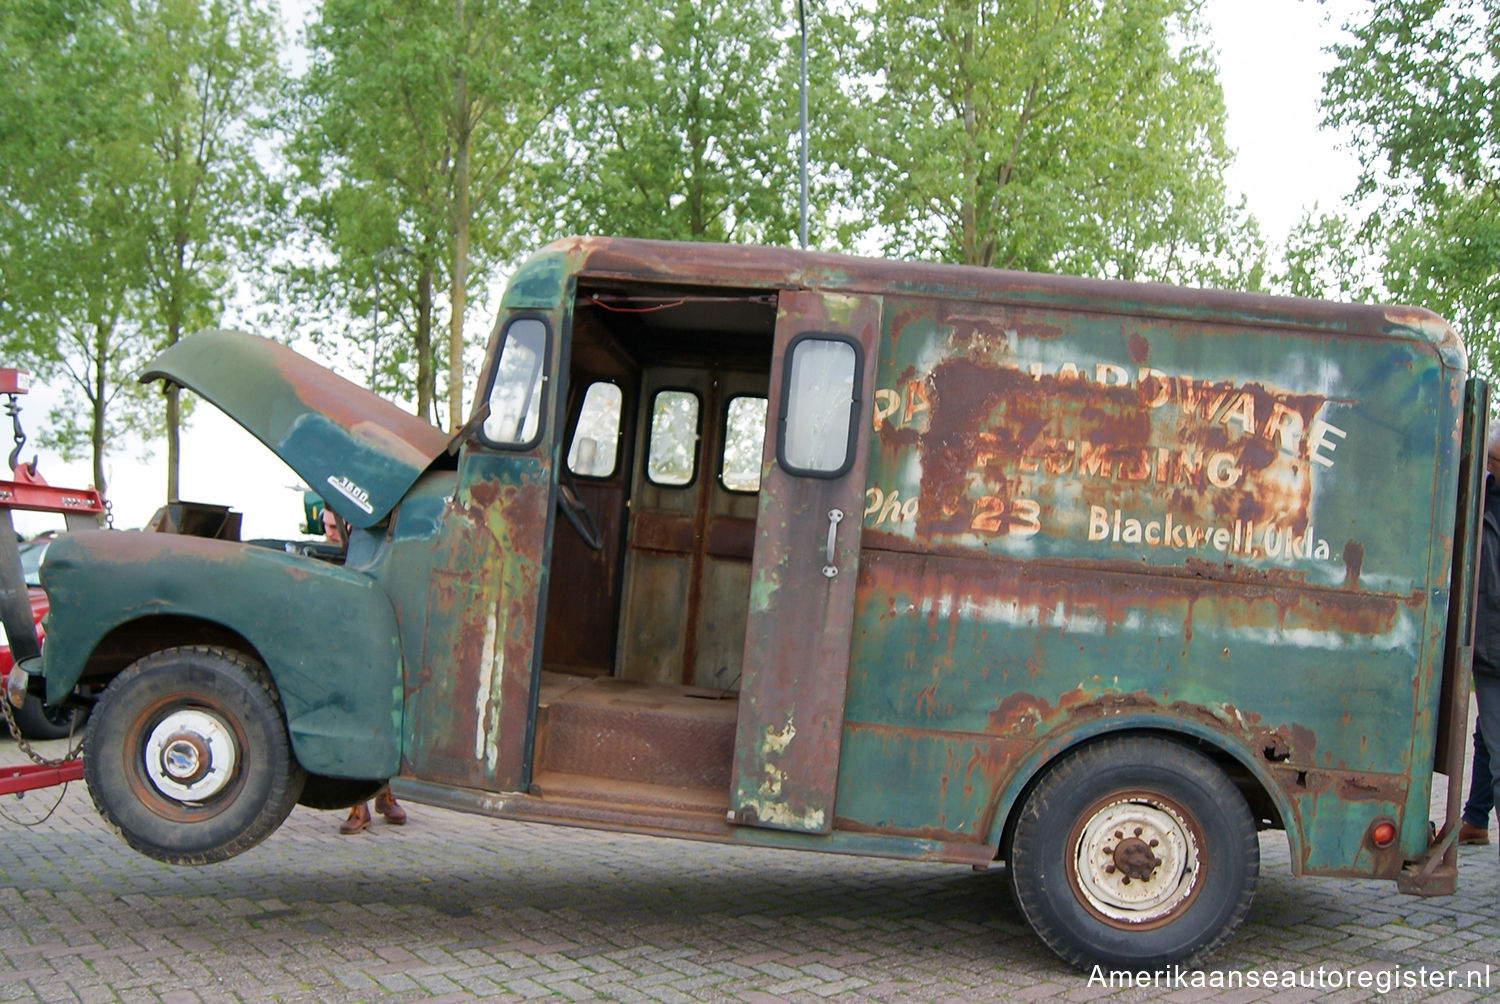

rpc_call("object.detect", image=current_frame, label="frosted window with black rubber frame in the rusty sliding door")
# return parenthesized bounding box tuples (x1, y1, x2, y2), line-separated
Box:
(777, 335, 861, 477)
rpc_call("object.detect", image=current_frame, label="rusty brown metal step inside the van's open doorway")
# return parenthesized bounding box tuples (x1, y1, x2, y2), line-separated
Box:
(534, 674, 740, 807)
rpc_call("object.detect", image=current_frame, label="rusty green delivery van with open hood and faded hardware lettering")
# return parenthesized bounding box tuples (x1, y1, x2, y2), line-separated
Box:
(17, 239, 1487, 968)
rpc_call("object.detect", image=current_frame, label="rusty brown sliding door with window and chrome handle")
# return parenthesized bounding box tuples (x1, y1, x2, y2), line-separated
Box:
(729, 291, 881, 833)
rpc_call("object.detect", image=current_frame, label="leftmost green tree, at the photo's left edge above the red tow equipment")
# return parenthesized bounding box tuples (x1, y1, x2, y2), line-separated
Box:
(0, 0, 159, 494)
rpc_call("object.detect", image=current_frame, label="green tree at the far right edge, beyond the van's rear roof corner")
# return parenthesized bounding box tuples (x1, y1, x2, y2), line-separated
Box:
(1323, 0, 1500, 374)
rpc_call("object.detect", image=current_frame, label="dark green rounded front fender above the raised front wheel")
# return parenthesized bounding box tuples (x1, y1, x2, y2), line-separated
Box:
(42, 531, 404, 779)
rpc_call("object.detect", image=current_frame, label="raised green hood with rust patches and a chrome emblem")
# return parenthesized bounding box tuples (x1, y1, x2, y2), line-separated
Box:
(141, 330, 449, 527)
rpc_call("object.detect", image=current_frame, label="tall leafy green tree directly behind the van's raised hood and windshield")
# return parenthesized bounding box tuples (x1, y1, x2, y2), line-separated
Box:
(291, 0, 578, 428)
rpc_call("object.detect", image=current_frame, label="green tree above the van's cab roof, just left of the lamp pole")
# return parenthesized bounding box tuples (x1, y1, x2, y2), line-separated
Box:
(534, 0, 816, 243)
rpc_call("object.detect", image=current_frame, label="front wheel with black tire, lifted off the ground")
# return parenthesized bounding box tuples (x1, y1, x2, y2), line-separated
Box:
(84, 647, 306, 864)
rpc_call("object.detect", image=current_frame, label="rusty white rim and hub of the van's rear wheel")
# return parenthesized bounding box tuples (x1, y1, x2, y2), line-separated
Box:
(1074, 795, 1199, 924)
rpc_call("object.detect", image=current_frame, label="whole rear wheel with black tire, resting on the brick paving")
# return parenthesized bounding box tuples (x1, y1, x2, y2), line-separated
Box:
(1007, 735, 1260, 971)
